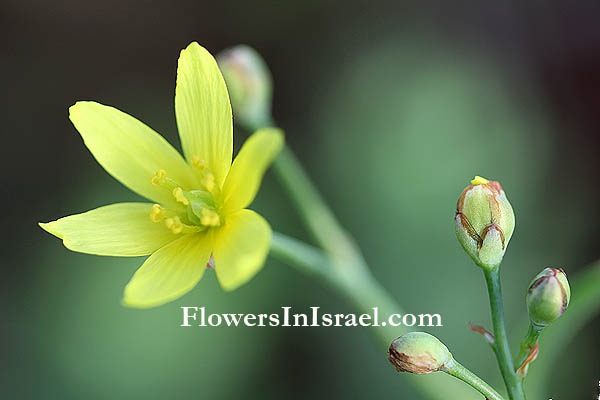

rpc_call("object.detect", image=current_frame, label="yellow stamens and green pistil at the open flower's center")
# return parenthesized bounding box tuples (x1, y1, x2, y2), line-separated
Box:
(150, 157, 225, 234)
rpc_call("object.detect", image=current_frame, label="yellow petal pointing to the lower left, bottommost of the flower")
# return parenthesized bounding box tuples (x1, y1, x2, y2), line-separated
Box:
(123, 233, 213, 308)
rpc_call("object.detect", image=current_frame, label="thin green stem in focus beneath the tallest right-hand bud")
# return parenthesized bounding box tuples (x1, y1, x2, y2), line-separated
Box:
(484, 267, 525, 400)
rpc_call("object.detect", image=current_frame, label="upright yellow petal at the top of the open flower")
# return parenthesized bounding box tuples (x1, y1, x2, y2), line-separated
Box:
(175, 42, 233, 186)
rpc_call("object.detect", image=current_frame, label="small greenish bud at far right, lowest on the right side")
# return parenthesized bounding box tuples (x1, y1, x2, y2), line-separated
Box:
(527, 268, 571, 326)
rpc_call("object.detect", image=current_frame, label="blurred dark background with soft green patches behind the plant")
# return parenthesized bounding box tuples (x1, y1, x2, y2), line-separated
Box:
(0, 0, 600, 399)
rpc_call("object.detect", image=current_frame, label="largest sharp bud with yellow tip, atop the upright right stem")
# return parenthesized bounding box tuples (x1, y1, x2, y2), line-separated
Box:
(455, 176, 515, 269)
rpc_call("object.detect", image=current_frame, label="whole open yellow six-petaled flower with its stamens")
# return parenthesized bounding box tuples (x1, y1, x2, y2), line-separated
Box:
(40, 42, 283, 308)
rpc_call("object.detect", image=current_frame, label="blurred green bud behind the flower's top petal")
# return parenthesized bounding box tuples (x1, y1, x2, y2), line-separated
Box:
(217, 45, 273, 129)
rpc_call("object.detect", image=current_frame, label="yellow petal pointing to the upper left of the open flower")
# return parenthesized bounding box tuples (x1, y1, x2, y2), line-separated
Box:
(69, 101, 197, 205)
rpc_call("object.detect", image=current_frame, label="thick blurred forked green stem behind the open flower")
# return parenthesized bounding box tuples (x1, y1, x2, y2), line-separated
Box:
(253, 120, 492, 400)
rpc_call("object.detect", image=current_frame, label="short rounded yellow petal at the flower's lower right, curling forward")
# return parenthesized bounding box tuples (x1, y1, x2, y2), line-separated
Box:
(213, 210, 271, 290)
